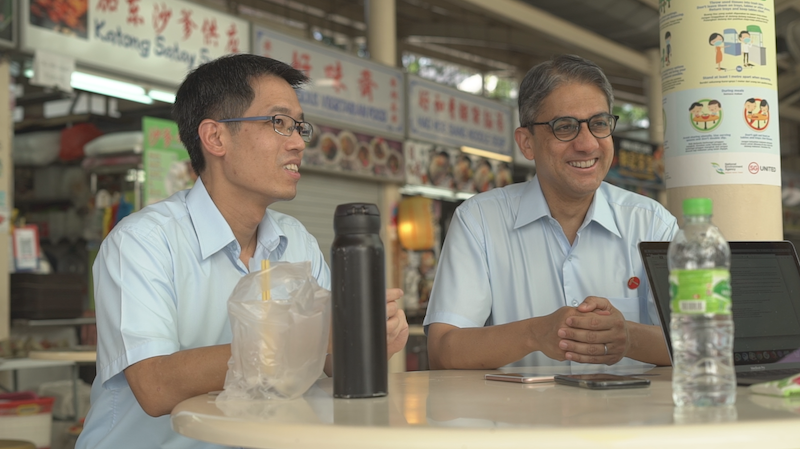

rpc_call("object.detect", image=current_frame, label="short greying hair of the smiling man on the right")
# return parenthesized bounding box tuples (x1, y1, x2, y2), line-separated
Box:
(518, 55, 614, 127)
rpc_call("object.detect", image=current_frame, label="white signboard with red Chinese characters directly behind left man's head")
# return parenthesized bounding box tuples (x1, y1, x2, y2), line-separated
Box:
(253, 26, 405, 137)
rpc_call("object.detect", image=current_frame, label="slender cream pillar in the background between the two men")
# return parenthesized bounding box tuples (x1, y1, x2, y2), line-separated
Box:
(364, 0, 406, 373)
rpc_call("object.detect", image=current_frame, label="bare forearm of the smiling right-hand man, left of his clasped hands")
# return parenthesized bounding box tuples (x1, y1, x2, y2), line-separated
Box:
(428, 318, 541, 369)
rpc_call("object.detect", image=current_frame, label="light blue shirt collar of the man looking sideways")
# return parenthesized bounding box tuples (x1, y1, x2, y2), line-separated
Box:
(186, 178, 289, 259)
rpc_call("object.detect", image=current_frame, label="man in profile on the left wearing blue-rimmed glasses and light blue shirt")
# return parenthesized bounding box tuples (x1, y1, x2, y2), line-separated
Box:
(76, 54, 408, 449)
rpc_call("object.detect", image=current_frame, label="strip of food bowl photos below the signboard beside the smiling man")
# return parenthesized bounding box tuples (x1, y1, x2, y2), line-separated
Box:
(405, 142, 513, 193)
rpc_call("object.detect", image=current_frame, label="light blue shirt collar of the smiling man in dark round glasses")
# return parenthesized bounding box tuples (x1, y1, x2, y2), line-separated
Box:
(514, 176, 622, 237)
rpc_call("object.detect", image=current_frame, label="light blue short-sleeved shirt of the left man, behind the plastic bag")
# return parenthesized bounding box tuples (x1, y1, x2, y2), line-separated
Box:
(76, 179, 330, 449)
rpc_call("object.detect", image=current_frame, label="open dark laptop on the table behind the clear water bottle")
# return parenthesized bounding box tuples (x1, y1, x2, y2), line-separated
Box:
(639, 241, 800, 385)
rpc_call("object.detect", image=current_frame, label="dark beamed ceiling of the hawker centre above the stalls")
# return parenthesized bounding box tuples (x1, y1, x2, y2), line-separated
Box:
(195, 0, 800, 117)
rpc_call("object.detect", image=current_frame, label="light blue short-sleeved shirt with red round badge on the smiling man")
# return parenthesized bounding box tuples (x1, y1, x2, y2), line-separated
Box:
(424, 177, 678, 366)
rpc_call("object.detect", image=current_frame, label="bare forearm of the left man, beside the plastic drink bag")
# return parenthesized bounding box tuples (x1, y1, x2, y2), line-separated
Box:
(125, 345, 231, 416)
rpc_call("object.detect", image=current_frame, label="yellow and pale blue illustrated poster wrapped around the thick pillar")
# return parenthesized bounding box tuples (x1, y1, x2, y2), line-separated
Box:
(660, 0, 781, 188)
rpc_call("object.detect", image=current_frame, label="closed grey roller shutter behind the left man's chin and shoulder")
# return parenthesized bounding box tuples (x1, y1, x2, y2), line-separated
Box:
(270, 171, 381, 265)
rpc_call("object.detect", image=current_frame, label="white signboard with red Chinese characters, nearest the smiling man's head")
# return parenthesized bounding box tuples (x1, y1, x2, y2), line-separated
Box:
(408, 76, 514, 157)
